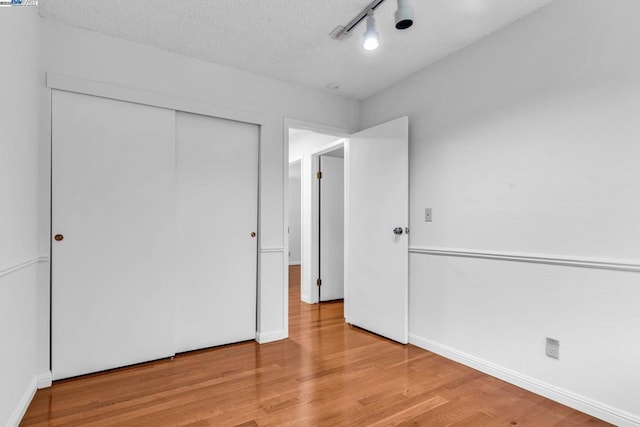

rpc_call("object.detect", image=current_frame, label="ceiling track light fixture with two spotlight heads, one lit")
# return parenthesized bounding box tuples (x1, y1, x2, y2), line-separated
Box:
(330, 0, 413, 50)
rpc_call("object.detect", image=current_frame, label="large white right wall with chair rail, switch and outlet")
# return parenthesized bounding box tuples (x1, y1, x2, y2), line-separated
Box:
(361, 0, 640, 425)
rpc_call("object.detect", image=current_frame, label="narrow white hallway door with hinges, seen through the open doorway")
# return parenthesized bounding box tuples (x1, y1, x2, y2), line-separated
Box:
(319, 156, 344, 301)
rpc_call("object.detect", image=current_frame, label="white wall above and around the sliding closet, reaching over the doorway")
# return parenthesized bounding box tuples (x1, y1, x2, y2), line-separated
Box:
(39, 19, 359, 354)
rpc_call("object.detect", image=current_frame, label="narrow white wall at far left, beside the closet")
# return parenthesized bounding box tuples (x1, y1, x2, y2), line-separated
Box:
(0, 7, 41, 425)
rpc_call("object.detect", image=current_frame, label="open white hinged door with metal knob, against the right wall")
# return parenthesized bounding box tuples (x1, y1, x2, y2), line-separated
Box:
(345, 117, 409, 343)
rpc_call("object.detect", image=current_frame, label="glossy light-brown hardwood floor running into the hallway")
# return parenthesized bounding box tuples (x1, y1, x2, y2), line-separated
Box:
(22, 267, 609, 427)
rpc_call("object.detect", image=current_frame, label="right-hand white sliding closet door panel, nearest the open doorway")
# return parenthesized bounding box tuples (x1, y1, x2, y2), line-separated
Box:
(176, 112, 259, 352)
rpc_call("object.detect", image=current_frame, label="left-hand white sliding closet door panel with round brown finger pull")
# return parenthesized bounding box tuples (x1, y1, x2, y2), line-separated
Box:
(51, 90, 175, 379)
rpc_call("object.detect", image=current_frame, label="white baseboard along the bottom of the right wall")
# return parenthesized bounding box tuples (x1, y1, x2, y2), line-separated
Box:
(409, 334, 640, 427)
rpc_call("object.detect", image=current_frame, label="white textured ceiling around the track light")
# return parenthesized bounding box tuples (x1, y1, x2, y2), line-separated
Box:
(40, 0, 551, 100)
